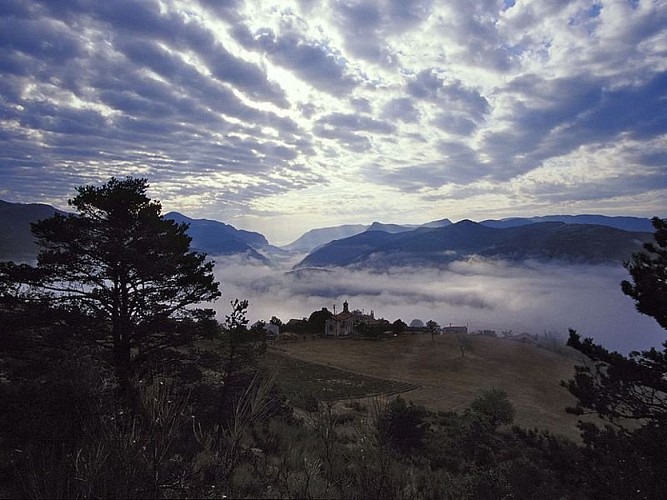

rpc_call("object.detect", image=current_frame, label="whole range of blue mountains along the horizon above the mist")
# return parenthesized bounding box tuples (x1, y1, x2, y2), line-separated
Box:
(0, 200, 653, 269)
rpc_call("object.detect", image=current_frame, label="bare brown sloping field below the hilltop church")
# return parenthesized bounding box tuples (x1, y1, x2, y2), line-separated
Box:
(272, 335, 581, 438)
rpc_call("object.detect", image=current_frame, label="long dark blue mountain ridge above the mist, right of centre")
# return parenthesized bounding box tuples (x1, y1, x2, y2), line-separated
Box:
(298, 220, 651, 268)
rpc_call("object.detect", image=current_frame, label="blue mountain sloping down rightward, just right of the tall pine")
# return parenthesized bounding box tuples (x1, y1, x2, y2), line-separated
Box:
(164, 212, 278, 263)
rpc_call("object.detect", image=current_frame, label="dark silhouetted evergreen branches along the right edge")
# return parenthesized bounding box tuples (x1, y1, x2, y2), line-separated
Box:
(565, 217, 667, 498)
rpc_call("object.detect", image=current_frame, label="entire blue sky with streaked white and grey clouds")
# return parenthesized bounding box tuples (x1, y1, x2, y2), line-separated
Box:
(0, 0, 667, 244)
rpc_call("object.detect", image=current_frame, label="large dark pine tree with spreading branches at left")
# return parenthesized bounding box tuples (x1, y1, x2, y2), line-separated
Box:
(2, 177, 220, 383)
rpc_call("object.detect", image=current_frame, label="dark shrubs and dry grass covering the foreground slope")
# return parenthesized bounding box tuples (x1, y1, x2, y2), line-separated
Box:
(0, 326, 581, 498)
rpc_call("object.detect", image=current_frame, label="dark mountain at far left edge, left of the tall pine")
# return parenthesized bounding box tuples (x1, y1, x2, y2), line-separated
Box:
(0, 200, 65, 262)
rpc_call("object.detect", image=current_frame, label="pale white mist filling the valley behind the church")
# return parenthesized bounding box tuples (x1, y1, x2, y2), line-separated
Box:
(207, 257, 667, 353)
